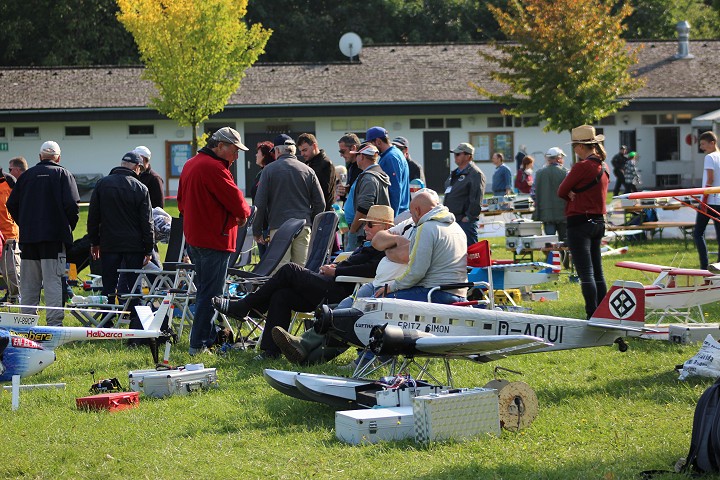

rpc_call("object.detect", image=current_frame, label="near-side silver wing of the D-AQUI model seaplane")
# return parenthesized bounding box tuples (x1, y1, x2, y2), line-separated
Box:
(408, 335, 552, 356)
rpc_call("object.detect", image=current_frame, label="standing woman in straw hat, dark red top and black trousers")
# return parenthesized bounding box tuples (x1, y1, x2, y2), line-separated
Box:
(558, 125, 610, 318)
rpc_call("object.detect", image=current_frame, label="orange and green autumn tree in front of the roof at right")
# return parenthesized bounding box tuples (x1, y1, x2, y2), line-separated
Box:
(473, 0, 643, 132)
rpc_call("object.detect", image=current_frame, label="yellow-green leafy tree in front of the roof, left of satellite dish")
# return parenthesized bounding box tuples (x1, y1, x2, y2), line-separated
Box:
(117, 0, 272, 152)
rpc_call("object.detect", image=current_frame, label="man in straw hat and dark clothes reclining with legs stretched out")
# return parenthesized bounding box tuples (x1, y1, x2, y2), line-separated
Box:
(213, 205, 394, 360)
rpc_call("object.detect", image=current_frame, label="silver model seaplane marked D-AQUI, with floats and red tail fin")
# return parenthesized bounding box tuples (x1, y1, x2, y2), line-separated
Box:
(264, 280, 653, 425)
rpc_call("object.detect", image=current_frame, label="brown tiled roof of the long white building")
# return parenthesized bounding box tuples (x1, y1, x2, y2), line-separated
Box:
(0, 41, 720, 111)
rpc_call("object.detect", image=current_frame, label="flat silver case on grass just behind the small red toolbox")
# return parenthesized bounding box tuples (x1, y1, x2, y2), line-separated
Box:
(128, 364, 217, 398)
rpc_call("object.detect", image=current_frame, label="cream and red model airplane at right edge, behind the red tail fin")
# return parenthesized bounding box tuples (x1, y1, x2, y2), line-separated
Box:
(615, 262, 720, 323)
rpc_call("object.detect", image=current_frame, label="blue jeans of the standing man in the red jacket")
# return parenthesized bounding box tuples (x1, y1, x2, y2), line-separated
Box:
(188, 245, 231, 349)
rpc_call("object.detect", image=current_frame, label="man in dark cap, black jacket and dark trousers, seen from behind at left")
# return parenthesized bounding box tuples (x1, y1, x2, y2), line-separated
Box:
(87, 152, 155, 328)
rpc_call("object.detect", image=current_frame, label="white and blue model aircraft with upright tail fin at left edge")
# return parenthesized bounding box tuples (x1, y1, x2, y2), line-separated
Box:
(0, 295, 172, 382)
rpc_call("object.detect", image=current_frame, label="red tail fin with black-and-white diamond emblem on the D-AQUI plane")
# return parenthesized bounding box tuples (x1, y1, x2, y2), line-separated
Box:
(589, 280, 645, 331)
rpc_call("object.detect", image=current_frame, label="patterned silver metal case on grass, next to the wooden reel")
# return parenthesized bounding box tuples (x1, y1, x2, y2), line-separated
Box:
(413, 388, 500, 443)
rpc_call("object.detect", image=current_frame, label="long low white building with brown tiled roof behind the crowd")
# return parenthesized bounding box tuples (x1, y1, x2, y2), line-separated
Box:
(0, 37, 720, 194)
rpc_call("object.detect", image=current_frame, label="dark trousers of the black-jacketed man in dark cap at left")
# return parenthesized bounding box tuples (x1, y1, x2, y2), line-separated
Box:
(100, 252, 145, 330)
